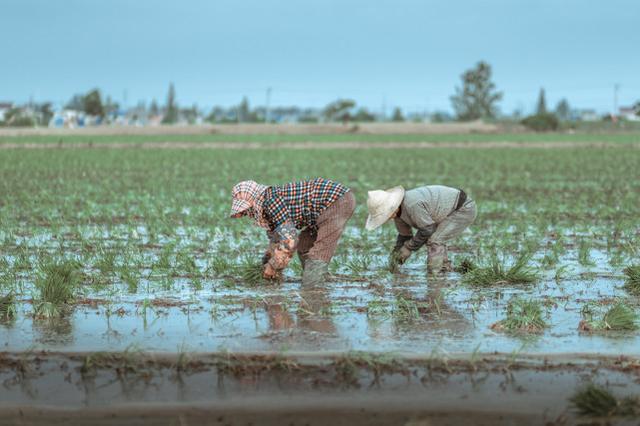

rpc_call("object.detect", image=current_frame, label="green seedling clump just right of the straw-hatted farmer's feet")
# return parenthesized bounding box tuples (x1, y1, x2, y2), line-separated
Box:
(462, 253, 538, 287)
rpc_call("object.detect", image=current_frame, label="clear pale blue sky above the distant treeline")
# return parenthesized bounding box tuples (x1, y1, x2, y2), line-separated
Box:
(0, 0, 640, 113)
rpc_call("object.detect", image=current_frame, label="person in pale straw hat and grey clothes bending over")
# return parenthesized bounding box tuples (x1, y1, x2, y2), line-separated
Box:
(366, 185, 476, 272)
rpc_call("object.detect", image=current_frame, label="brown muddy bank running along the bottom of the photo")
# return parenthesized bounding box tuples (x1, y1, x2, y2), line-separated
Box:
(0, 351, 640, 426)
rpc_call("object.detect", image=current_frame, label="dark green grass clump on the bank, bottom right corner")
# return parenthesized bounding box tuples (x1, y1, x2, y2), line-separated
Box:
(569, 383, 640, 417)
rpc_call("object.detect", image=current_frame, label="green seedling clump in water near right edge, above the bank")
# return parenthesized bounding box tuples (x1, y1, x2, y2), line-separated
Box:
(578, 301, 638, 332)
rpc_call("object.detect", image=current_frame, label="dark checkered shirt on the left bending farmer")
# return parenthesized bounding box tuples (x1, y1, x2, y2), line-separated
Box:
(262, 178, 349, 231)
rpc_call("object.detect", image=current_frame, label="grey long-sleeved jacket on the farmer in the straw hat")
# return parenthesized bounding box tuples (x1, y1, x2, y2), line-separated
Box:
(394, 185, 460, 251)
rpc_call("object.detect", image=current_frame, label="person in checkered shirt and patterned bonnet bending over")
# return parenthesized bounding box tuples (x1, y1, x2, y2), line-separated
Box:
(231, 178, 356, 285)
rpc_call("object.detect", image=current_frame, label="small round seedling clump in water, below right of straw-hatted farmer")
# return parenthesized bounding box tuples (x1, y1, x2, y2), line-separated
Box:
(491, 298, 548, 334)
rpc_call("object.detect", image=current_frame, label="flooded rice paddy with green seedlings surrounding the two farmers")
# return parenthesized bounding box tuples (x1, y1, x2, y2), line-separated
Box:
(0, 144, 640, 425)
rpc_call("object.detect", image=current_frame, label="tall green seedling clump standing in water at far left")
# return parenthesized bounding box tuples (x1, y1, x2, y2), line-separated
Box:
(34, 260, 81, 318)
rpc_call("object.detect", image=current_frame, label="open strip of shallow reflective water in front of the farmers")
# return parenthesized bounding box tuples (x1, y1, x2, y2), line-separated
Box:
(0, 251, 640, 355)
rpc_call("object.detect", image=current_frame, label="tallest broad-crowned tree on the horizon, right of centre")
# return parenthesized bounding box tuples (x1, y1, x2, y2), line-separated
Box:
(451, 61, 503, 121)
